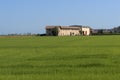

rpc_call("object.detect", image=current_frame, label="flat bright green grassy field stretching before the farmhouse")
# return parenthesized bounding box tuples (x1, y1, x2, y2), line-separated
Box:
(0, 36, 120, 80)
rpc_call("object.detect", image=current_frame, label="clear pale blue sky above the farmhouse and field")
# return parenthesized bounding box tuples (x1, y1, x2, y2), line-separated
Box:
(0, 0, 120, 34)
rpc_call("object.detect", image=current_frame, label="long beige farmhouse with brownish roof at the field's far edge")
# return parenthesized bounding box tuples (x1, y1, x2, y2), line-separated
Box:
(46, 25, 90, 36)
